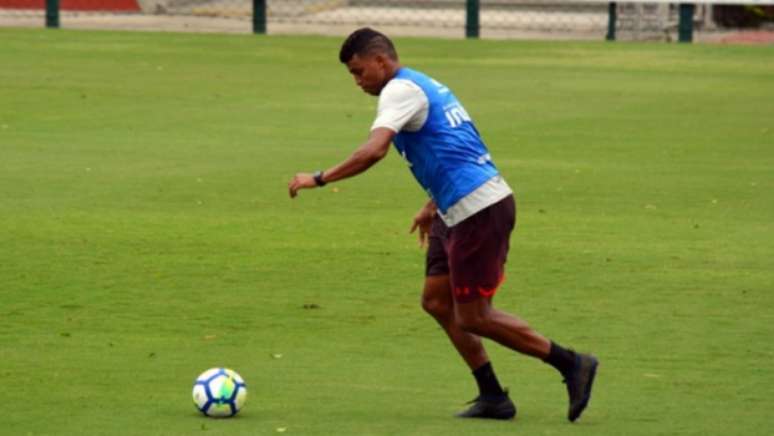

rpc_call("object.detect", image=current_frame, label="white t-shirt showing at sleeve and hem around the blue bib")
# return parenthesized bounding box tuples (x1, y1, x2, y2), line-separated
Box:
(371, 79, 512, 227)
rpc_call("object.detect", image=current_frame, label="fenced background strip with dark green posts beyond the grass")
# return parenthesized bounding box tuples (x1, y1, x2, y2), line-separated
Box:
(0, 0, 774, 42)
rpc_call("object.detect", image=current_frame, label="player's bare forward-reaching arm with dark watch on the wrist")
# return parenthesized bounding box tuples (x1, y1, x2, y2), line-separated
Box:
(288, 127, 395, 198)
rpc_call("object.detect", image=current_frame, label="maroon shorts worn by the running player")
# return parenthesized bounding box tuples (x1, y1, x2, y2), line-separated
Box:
(425, 195, 516, 303)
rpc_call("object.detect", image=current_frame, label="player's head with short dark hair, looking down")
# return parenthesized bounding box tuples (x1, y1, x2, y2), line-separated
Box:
(339, 27, 400, 95)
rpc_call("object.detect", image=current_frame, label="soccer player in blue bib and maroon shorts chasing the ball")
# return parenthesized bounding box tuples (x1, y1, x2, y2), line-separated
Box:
(288, 28, 598, 421)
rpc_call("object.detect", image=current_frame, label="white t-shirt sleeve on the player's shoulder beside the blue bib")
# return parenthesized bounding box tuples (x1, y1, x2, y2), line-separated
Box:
(371, 79, 428, 133)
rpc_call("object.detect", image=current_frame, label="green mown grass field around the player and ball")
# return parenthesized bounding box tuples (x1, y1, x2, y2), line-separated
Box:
(0, 29, 774, 436)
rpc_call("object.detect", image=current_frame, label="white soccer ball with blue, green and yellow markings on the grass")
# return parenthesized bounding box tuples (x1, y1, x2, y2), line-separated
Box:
(193, 368, 247, 418)
